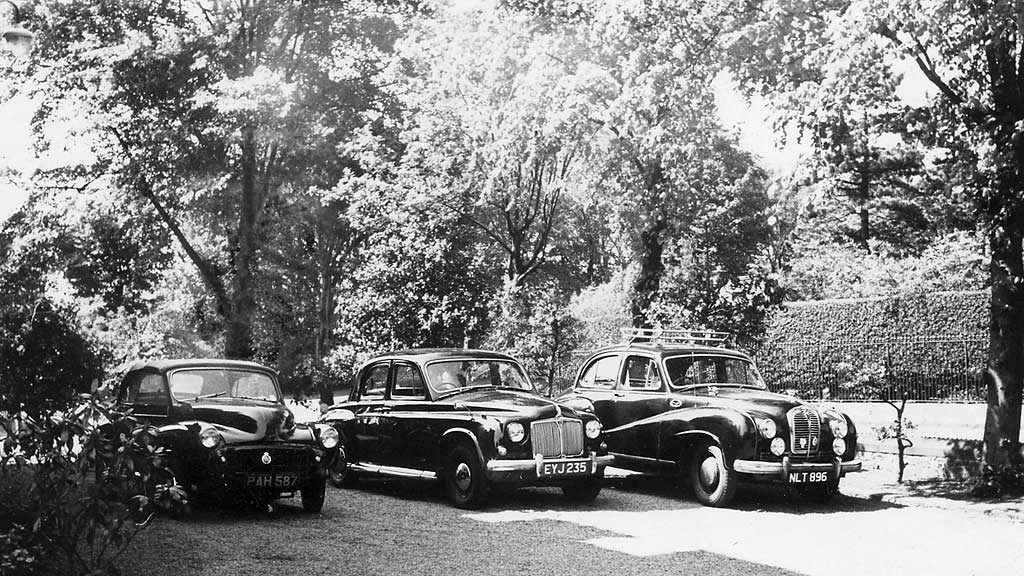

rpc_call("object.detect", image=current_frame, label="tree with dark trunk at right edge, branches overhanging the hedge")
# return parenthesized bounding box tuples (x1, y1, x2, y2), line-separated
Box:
(730, 0, 1024, 466)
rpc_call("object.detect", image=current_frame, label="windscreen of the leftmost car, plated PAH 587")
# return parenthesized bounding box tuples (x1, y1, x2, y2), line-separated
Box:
(168, 368, 281, 402)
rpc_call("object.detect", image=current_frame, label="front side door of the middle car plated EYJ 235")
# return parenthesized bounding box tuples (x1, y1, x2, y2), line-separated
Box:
(380, 361, 436, 470)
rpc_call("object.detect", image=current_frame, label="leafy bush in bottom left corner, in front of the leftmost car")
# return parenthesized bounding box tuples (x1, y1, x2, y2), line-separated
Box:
(0, 395, 186, 575)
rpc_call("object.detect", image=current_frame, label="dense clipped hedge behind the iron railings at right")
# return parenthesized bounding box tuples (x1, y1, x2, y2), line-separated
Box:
(755, 291, 989, 402)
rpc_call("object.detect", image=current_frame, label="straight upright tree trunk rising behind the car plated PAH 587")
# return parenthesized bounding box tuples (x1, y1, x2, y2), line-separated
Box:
(224, 126, 260, 360)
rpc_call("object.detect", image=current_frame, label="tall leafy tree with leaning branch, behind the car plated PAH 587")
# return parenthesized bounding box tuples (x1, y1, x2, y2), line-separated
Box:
(32, 2, 413, 358)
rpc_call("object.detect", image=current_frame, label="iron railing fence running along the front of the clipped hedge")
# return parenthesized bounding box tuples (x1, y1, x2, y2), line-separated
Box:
(755, 336, 988, 403)
